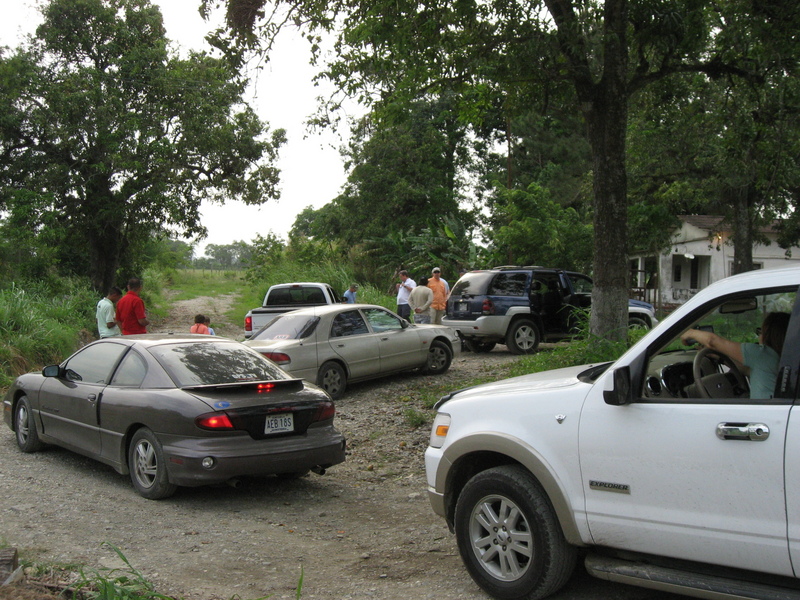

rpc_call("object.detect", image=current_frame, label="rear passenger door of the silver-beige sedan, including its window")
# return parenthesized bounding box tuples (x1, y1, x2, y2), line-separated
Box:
(328, 310, 380, 379)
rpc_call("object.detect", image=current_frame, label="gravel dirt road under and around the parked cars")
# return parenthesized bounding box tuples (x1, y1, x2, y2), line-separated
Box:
(0, 298, 688, 600)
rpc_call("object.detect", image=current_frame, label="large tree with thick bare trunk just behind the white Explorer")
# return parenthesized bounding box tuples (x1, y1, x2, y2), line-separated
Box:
(203, 0, 796, 337)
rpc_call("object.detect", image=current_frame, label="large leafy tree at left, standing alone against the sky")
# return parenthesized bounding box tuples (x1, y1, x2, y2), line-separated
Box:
(0, 0, 285, 289)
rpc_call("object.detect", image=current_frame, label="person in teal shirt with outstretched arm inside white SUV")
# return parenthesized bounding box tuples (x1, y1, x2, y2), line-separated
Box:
(681, 312, 790, 399)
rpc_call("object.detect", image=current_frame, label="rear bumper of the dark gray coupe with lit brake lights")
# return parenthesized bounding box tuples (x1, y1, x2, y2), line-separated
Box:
(159, 427, 345, 487)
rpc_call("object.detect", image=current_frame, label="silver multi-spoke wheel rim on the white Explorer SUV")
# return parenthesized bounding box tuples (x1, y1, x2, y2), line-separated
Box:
(469, 495, 533, 581)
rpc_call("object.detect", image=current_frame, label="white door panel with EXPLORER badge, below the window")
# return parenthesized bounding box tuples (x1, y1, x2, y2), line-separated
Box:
(580, 398, 792, 575)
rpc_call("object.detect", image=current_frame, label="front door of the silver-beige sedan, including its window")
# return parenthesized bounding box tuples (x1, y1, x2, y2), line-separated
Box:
(362, 308, 428, 373)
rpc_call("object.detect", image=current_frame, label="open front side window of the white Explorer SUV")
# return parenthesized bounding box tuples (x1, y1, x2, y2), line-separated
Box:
(643, 290, 797, 403)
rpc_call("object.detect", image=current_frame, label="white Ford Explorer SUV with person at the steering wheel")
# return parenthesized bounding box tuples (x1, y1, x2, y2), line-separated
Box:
(425, 267, 800, 599)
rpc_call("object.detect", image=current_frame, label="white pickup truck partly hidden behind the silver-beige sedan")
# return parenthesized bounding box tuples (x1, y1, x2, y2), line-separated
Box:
(244, 282, 342, 339)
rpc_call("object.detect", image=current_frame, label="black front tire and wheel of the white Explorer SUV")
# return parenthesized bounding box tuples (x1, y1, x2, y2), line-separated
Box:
(455, 465, 577, 600)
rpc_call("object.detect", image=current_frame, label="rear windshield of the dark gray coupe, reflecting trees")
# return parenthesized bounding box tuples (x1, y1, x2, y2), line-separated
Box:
(149, 342, 289, 387)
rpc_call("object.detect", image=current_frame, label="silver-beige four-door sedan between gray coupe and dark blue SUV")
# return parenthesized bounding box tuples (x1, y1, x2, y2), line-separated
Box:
(245, 304, 461, 399)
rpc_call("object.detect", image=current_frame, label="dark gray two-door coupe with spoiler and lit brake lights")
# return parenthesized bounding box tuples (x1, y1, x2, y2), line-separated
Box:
(3, 334, 345, 499)
